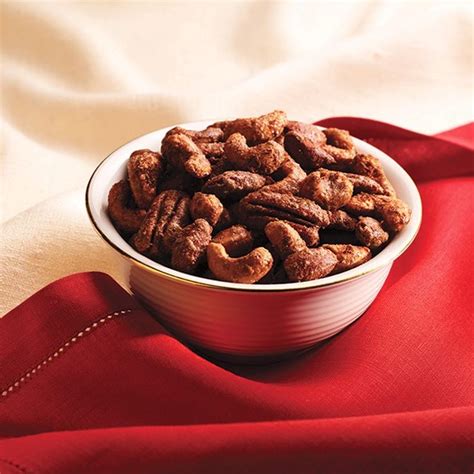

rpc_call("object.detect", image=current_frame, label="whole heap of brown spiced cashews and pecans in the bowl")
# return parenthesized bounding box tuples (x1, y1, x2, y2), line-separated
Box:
(108, 111, 411, 283)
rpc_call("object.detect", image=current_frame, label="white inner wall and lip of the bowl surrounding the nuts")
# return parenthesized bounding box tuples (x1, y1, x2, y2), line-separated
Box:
(86, 121, 422, 291)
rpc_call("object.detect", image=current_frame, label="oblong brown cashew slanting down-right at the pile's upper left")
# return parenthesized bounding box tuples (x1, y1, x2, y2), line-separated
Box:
(161, 133, 212, 178)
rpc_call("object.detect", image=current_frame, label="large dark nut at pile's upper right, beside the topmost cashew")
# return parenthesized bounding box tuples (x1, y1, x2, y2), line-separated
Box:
(284, 122, 336, 171)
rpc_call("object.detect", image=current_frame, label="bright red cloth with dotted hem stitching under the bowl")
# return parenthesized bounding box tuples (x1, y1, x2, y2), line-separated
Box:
(0, 118, 474, 474)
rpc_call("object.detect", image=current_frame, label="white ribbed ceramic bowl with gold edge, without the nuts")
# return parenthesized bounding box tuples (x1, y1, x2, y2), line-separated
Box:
(86, 122, 422, 362)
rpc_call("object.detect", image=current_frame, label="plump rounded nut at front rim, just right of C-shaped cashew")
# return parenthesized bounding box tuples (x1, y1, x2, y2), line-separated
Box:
(283, 247, 337, 281)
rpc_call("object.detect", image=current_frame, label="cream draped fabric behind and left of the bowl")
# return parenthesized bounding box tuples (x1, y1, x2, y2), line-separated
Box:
(0, 0, 474, 314)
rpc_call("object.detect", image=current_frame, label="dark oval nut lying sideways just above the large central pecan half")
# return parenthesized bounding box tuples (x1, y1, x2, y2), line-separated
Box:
(202, 171, 271, 200)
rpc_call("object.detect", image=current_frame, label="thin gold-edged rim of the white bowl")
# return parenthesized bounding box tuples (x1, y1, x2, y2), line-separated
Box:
(85, 119, 422, 293)
